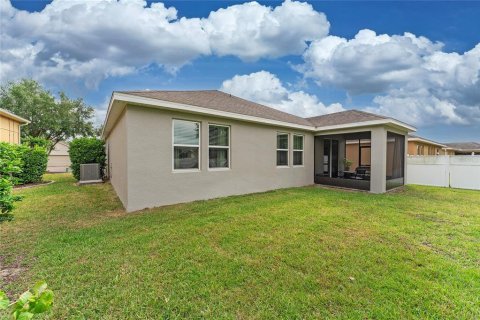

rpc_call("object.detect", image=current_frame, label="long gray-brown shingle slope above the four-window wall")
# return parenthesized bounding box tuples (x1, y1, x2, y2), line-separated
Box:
(117, 90, 312, 126)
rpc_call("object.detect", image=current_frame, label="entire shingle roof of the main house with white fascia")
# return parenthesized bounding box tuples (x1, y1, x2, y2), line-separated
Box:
(102, 90, 415, 137)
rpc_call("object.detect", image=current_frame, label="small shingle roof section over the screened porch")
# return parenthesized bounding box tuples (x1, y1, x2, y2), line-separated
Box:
(307, 110, 389, 127)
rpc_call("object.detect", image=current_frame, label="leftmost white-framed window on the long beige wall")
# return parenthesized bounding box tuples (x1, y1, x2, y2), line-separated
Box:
(173, 120, 200, 170)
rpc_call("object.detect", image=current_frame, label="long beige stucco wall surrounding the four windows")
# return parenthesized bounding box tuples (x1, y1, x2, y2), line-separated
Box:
(122, 106, 314, 211)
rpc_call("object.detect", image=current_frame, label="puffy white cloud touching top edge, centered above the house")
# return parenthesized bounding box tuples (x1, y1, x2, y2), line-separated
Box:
(202, 0, 330, 60)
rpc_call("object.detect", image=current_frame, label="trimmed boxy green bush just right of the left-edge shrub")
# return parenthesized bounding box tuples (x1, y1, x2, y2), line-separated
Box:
(15, 145, 48, 183)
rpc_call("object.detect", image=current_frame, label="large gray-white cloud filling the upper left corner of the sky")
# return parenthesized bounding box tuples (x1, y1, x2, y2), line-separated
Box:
(0, 0, 211, 87)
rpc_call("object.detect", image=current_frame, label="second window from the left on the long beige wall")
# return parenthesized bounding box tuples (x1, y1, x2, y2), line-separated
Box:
(208, 124, 230, 169)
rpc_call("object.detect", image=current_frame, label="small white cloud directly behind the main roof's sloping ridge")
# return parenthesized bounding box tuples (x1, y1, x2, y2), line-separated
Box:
(220, 70, 344, 117)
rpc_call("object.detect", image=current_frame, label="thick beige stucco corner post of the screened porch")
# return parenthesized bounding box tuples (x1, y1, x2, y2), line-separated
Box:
(370, 127, 387, 193)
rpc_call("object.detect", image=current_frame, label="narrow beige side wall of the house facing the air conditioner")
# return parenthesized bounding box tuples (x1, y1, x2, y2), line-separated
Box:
(106, 112, 128, 208)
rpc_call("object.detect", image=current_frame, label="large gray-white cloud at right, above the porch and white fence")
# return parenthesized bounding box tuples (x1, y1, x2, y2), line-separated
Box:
(297, 30, 480, 126)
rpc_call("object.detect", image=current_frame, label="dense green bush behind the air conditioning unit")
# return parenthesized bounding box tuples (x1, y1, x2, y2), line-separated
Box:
(68, 138, 107, 180)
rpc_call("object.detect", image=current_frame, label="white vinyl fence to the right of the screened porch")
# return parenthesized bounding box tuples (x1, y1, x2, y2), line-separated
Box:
(407, 156, 480, 190)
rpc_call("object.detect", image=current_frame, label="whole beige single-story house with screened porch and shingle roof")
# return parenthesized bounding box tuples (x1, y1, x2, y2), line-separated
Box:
(102, 90, 415, 211)
